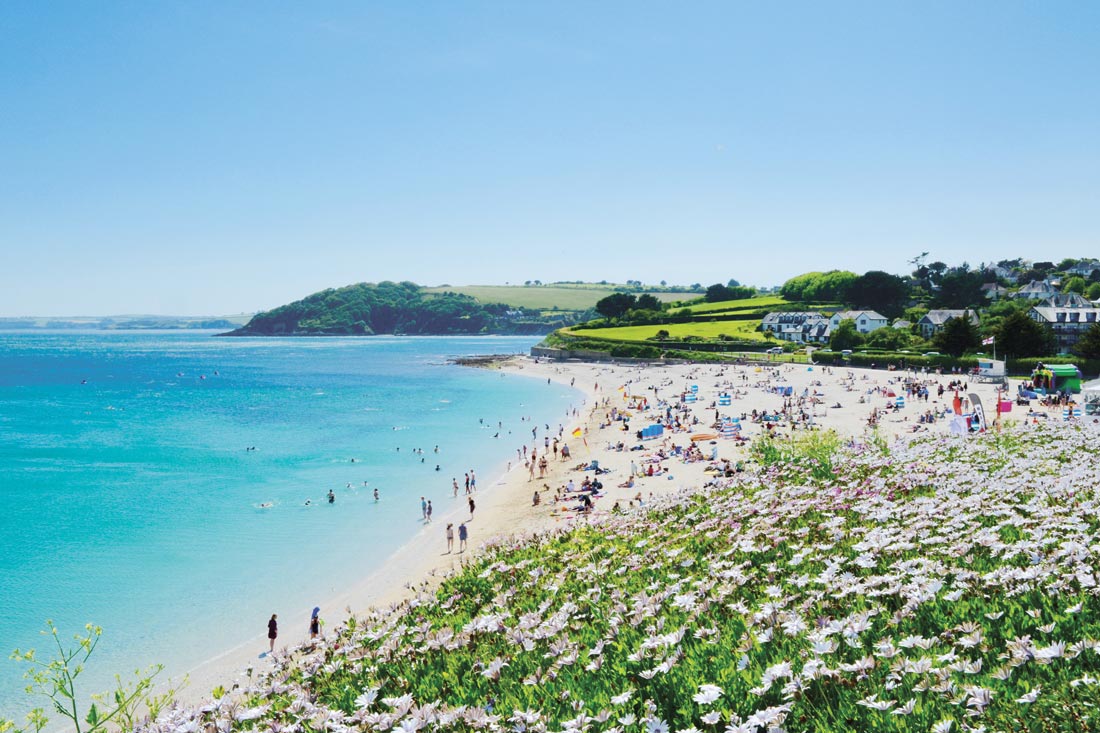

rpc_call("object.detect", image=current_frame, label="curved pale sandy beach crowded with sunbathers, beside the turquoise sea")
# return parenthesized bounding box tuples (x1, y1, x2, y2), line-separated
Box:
(173, 357, 1020, 703)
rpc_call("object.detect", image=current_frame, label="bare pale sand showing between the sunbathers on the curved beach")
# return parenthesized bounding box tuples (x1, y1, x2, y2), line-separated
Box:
(180, 358, 1021, 702)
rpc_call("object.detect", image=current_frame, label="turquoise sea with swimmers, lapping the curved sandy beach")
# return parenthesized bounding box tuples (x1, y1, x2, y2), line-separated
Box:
(0, 331, 580, 716)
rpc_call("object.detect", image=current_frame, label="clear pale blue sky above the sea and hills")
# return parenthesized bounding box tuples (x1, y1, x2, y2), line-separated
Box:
(0, 0, 1100, 316)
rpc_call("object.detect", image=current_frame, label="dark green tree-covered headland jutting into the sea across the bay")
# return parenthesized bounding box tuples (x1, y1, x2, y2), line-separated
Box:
(226, 282, 551, 336)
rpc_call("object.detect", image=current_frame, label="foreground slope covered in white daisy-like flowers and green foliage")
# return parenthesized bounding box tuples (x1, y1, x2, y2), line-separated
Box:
(160, 425, 1100, 733)
